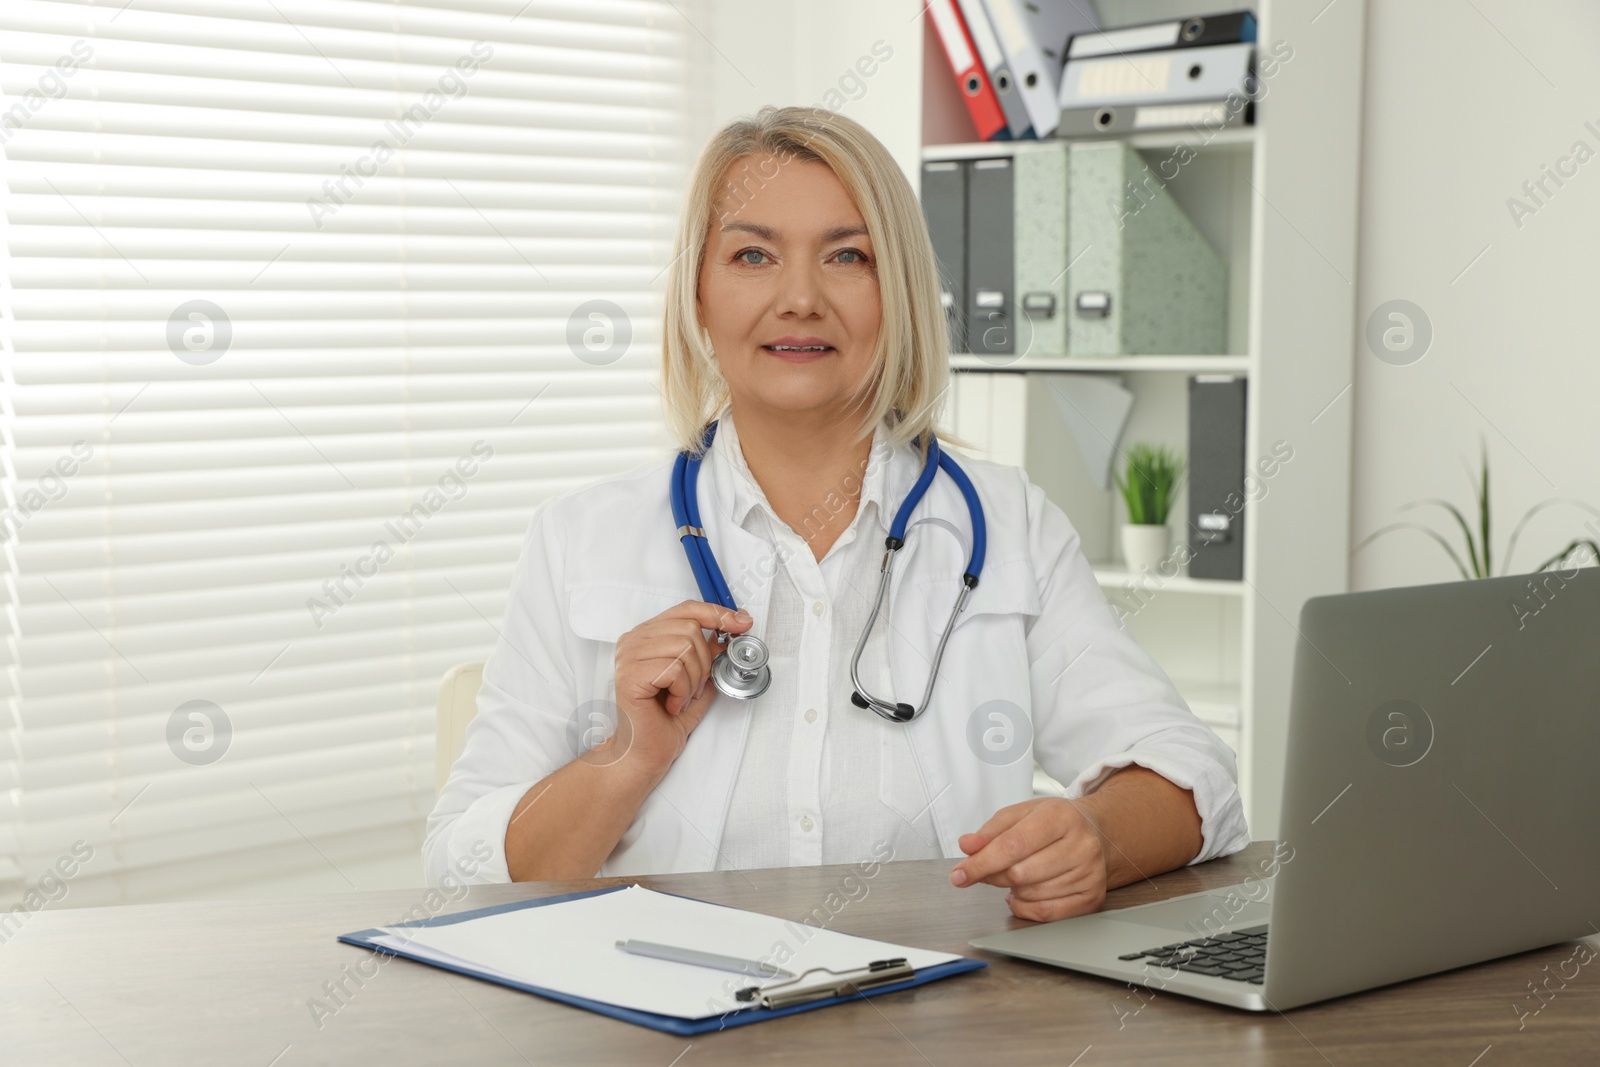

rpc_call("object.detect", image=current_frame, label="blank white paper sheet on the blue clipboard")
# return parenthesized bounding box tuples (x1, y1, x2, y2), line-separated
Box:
(374, 886, 960, 1019)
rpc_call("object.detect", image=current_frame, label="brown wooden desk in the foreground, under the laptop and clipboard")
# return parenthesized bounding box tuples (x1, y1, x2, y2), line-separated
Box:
(0, 843, 1600, 1067)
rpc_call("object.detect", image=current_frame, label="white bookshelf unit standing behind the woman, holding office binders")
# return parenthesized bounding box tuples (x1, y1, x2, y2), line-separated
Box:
(922, 0, 1365, 838)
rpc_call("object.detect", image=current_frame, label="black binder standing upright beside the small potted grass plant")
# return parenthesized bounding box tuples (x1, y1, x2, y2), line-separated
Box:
(1189, 374, 1246, 581)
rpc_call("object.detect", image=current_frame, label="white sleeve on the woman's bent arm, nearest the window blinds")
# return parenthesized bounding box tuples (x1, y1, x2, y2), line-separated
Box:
(422, 499, 576, 885)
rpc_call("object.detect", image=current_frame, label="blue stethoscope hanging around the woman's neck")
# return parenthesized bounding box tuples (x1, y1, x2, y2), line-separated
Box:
(672, 419, 987, 723)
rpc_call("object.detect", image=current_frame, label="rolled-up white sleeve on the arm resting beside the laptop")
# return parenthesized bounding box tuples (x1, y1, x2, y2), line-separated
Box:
(1024, 478, 1250, 862)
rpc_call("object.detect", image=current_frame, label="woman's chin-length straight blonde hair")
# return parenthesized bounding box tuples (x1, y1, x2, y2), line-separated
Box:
(661, 104, 965, 456)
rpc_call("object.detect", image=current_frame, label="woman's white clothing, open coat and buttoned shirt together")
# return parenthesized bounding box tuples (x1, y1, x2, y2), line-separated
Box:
(422, 413, 1250, 881)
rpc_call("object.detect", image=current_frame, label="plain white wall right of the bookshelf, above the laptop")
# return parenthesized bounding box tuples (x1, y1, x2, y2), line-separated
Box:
(1339, 0, 1600, 589)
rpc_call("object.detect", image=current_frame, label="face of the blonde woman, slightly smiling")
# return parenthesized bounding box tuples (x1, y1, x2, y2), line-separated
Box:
(696, 157, 882, 416)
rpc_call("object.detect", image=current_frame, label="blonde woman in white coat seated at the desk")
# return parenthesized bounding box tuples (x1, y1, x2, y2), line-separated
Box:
(424, 107, 1248, 920)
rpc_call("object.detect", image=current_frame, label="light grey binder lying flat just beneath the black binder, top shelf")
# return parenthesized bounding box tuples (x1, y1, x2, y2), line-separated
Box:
(1059, 42, 1256, 110)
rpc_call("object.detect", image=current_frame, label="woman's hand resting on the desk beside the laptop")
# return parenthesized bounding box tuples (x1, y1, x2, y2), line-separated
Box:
(950, 797, 1109, 923)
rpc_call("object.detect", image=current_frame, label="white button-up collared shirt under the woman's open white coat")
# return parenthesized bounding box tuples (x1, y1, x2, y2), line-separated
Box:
(712, 413, 939, 869)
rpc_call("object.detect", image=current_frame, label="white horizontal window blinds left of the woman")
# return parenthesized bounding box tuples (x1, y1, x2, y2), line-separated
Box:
(0, 0, 693, 908)
